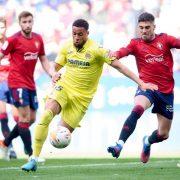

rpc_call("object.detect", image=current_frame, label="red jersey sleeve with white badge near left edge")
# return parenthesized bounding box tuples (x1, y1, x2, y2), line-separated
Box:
(1, 38, 15, 55)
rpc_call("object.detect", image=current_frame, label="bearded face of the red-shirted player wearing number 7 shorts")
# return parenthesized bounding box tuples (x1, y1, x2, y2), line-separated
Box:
(19, 16, 33, 36)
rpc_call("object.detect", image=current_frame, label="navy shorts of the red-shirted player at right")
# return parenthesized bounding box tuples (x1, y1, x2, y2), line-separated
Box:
(135, 88, 174, 120)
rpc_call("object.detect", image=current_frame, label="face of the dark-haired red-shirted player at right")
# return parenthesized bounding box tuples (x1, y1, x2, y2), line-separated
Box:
(138, 21, 155, 41)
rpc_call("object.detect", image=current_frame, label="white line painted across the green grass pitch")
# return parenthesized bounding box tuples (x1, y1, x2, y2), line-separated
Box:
(0, 160, 178, 171)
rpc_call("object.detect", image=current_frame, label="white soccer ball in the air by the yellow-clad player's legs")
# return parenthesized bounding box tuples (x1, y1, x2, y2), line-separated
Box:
(50, 126, 71, 148)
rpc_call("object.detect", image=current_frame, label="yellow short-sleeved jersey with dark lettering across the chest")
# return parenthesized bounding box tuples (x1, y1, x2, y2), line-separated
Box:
(55, 39, 113, 99)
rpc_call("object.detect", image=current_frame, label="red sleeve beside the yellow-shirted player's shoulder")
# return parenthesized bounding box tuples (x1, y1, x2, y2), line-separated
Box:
(115, 39, 135, 59)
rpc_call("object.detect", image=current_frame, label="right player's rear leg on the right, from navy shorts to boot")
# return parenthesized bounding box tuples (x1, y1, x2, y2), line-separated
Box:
(141, 92, 174, 163)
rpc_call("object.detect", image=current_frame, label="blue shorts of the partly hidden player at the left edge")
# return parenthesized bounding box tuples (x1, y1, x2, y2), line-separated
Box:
(0, 81, 11, 103)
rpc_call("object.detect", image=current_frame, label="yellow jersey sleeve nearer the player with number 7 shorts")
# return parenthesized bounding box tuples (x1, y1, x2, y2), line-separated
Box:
(55, 45, 67, 66)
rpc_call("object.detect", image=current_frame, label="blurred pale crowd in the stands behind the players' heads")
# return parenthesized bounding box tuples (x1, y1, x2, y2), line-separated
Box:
(0, 0, 180, 70)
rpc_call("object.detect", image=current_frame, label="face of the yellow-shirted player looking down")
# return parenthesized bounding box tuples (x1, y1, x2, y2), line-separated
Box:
(72, 26, 89, 48)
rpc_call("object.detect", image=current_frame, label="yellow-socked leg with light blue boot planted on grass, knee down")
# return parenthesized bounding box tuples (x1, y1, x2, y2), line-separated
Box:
(22, 99, 61, 171)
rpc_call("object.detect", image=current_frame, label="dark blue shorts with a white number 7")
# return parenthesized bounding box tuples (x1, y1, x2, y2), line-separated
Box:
(10, 88, 38, 110)
